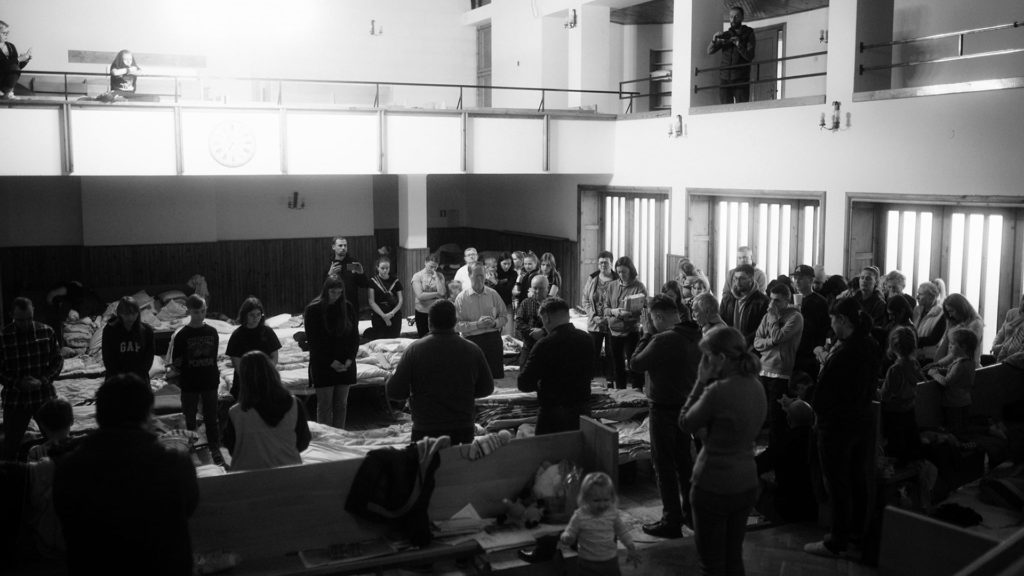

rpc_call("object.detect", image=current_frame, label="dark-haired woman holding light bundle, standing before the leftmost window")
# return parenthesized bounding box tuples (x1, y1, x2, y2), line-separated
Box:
(604, 256, 647, 389)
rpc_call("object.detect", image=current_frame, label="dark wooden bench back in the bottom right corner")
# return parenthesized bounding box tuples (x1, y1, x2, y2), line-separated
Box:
(879, 506, 998, 576)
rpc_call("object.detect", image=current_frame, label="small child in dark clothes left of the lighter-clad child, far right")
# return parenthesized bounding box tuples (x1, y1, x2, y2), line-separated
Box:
(882, 326, 925, 463)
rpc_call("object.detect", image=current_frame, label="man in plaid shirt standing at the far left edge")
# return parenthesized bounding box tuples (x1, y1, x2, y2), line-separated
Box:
(0, 297, 63, 460)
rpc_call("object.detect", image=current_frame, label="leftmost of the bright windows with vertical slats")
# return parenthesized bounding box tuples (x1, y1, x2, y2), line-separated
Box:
(602, 193, 674, 294)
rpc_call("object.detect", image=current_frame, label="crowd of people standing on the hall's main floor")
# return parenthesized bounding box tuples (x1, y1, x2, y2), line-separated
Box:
(0, 230, 1024, 574)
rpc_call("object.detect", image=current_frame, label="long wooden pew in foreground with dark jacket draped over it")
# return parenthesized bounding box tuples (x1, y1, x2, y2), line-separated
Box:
(189, 417, 618, 574)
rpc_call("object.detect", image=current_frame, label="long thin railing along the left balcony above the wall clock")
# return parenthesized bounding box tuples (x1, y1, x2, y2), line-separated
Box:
(14, 70, 637, 112)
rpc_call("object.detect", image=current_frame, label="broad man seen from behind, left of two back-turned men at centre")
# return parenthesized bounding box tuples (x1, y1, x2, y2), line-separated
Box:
(387, 300, 495, 444)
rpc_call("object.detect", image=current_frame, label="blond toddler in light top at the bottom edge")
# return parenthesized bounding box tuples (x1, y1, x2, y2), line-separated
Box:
(561, 472, 640, 576)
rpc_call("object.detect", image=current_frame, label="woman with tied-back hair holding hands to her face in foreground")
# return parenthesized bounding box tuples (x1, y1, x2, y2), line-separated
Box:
(679, 327, 768, 575)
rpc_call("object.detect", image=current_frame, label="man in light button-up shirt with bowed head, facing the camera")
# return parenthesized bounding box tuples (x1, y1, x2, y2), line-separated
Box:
(455, 262, 507, 378)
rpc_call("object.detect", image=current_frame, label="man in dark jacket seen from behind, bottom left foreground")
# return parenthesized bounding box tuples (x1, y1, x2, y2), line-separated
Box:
(53, 374, 199, 576)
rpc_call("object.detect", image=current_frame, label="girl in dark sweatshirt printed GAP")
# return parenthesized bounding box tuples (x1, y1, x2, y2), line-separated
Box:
(102, 296, 156, 382)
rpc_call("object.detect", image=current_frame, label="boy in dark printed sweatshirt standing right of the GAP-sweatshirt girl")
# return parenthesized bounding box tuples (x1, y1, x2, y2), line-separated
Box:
(171, 294, 224, 465)
